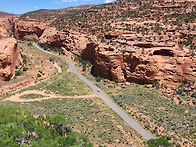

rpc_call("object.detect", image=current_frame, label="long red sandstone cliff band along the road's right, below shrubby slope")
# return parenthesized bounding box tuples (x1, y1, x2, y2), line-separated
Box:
(14, 21, 196, 88)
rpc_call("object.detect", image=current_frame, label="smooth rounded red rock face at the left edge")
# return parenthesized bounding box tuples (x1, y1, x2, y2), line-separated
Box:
(0, 38, 20, 81)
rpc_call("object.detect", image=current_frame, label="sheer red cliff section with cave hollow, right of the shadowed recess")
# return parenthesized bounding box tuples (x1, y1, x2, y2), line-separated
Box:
(89, 45, 196, 88)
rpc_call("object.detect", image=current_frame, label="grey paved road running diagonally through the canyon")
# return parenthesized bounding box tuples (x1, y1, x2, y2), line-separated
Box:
(33, 43, 155, 140)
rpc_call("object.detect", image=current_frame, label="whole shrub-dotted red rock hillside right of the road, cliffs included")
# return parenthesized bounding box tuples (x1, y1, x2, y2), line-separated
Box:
(16, 1, 196, 88)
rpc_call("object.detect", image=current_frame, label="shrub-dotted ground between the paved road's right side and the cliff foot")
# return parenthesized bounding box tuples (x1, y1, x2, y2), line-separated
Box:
(80, 74, 195, 146)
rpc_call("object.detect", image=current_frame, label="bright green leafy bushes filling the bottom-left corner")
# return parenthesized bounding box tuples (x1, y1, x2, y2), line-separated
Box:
(0, 106, 92, 147)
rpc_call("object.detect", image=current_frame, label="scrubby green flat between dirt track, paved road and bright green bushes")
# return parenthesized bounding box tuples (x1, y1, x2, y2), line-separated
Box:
(0, 98, 143, 146)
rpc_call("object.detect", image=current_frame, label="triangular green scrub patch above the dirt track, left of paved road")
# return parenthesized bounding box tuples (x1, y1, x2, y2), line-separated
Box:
(23, 71, 92, 96)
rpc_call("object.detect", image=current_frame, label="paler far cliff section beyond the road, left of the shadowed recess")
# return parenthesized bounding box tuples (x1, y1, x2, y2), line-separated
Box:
(14, 21, 89, 56)
